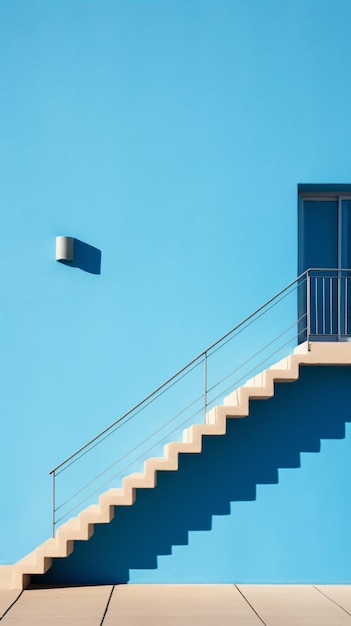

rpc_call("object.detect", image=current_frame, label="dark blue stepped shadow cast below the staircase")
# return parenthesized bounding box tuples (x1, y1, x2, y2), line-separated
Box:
(32, 367, 351, 584)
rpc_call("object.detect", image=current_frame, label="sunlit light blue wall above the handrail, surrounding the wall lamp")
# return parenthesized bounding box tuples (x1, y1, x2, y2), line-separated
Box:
(0, 0, 351, 563)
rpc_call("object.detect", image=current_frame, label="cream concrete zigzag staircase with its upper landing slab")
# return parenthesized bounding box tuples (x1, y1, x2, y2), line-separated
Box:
(0, 342, 351, 589)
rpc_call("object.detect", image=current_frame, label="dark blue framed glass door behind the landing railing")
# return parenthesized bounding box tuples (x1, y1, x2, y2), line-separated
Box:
(298, 184, 351, 343)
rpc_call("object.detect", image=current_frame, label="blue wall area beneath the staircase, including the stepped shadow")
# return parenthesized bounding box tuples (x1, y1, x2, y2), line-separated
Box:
(34, 367, 351, 583)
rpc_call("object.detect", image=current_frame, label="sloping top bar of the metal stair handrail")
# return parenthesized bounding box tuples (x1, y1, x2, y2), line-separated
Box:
(49, 268, 310, 475)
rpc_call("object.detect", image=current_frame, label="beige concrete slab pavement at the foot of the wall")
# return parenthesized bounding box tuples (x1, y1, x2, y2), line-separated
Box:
(0, 585, 351, 626)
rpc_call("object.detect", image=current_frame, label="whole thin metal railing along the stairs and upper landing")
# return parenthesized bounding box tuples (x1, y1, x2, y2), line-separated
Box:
(50, 268, 351, 536)
